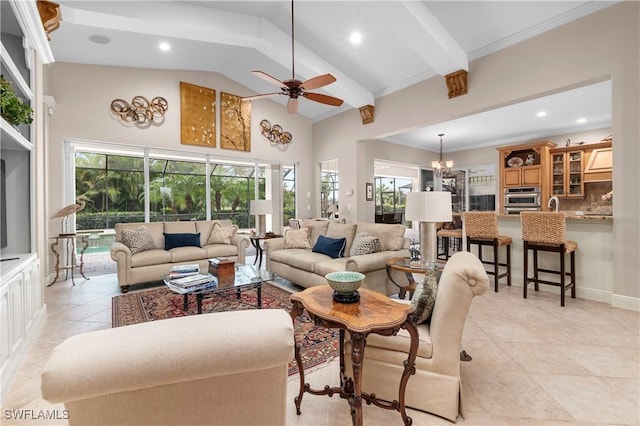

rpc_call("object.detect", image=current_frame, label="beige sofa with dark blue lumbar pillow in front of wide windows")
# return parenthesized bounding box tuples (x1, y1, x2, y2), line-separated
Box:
(111, 220, 249, 293)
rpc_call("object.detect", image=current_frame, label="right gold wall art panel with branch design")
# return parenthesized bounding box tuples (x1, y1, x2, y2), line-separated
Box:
(220, 92, 251, 152)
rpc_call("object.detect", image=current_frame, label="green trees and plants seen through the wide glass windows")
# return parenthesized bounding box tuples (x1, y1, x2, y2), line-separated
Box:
(76, 152, 295, 230)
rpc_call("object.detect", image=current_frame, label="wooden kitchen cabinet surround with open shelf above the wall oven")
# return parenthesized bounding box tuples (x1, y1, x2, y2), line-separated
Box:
(498, 141, 556, 210)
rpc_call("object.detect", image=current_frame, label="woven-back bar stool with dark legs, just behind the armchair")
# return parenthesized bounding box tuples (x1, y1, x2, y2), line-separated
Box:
(464, 212, 512, 292)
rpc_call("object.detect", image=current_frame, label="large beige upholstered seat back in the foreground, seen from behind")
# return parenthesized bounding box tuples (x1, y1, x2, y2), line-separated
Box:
(41, 309, 294, 426)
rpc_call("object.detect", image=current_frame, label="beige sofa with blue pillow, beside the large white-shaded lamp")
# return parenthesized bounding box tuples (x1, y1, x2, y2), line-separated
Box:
(264, 219, 410, 295)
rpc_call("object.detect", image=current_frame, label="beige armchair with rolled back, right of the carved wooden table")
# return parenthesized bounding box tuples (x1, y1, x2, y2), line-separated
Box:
(345, 252, 489, 421)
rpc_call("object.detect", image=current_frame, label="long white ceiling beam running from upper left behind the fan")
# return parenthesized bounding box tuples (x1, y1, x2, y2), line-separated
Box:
(62, 2, 374, 108)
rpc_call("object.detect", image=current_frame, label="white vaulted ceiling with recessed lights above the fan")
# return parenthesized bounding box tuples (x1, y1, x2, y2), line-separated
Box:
(51, 0, 614, 149)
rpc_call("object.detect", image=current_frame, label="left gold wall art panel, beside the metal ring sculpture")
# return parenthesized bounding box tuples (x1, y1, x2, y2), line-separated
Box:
(180, 81, 216, 148)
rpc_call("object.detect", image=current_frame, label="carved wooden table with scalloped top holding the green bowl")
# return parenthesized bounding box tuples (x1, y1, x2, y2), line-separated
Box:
(291, 285, 418, 426)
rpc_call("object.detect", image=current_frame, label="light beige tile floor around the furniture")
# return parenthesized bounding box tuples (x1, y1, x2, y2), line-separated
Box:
(0, 258, 640, 426)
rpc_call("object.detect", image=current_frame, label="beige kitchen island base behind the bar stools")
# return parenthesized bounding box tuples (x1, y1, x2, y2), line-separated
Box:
(480, 212, 613, 307)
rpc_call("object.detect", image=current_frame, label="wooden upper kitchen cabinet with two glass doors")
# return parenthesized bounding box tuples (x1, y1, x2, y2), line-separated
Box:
(551, 148, 584, 198)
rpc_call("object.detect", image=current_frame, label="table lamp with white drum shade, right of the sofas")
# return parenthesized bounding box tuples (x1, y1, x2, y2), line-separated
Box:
(405, 191, 453, 265)
